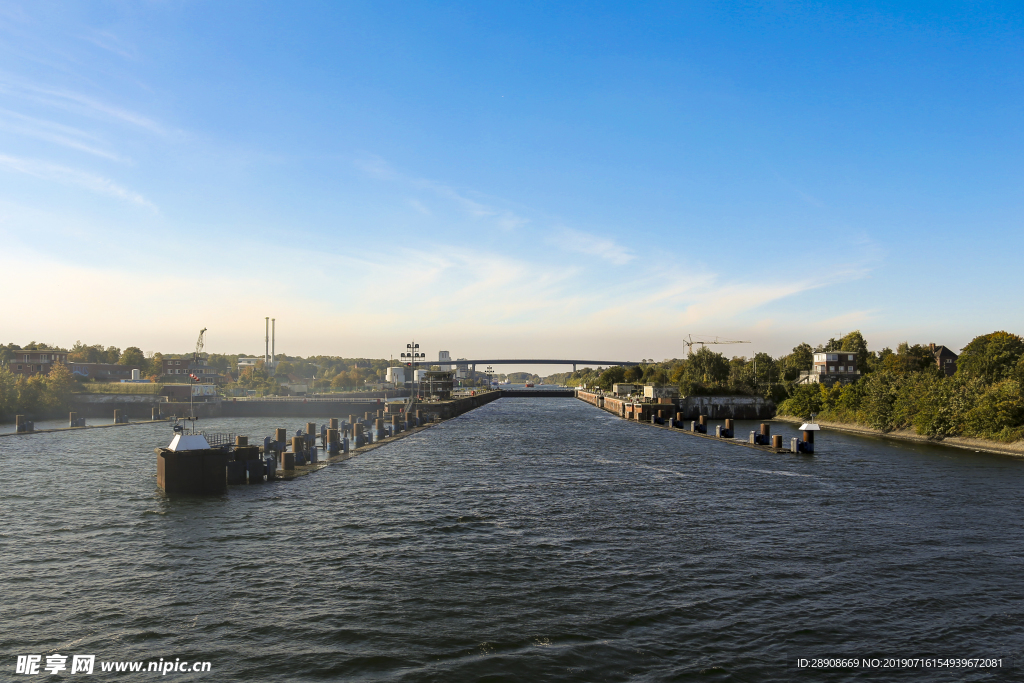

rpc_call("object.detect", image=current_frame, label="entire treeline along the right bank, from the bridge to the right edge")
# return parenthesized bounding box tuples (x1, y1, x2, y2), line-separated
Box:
(545, 331, 1024, 441)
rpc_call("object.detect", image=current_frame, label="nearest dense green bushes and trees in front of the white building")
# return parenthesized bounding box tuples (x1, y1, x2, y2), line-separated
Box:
(778, 332, 1024, 441)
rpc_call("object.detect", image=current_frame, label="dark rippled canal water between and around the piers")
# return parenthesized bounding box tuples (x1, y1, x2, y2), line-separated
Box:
(0, 398, 1024, 682)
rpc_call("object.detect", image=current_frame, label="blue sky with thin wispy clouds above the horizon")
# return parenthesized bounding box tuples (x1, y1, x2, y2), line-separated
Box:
(0, 0, 1024, 374)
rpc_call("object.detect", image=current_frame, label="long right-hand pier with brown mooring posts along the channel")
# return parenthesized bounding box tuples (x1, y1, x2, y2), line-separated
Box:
(575, 389, 819, 456)
